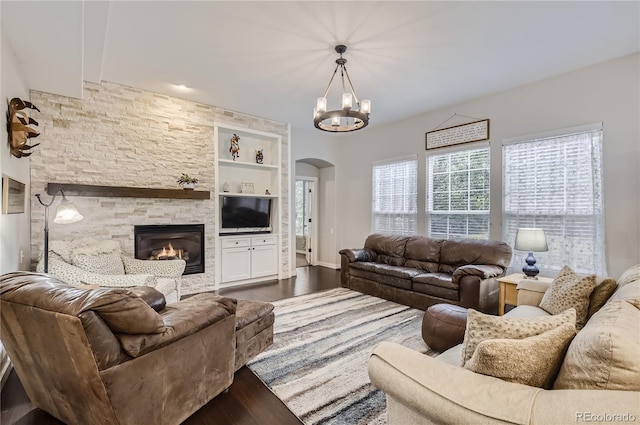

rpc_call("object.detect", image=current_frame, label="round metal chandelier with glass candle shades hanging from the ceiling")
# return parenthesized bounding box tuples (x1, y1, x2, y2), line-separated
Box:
(313, 44, 371, 132)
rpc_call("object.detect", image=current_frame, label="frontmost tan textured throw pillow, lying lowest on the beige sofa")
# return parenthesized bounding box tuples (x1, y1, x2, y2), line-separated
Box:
(464, 323, 576, 389)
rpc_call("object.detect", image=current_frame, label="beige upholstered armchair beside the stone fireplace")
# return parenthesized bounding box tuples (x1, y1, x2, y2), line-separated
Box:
(36, 238, 186, 303)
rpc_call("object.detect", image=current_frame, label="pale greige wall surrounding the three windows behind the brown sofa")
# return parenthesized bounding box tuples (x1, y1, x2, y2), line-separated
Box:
(336, 54, 640, 277)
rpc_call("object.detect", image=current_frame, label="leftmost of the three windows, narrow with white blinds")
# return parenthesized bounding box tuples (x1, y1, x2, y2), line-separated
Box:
(371, 155, 418, 235)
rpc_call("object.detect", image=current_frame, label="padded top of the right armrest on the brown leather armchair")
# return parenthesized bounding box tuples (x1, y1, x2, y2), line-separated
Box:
(117, 293, 237, 357)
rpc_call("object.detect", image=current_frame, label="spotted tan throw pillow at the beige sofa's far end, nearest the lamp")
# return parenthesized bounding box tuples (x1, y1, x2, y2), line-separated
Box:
(540, 266, 596, 330)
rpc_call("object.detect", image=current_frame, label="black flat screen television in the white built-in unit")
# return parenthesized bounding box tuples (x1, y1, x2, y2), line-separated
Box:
(220, 196, 271, 233)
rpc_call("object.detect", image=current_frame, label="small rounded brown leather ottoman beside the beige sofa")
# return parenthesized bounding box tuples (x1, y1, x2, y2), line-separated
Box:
(422, 304, 467, 353)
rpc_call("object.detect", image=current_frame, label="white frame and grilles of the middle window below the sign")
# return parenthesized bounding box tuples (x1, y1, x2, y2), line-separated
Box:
(425, 142, 491, 239)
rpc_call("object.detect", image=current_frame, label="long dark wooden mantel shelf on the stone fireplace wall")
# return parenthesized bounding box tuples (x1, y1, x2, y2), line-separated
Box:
(47, 183, 211, 199)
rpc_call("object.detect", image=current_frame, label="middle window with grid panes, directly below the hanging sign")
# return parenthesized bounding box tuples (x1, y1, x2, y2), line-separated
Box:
(426, 147, 489, 239)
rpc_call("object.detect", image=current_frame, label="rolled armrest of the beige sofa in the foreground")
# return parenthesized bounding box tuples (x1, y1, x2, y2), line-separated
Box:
(368, 342, 543, 424)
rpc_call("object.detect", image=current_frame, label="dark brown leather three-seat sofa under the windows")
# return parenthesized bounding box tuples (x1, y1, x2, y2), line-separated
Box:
(340, 234, 512, 314)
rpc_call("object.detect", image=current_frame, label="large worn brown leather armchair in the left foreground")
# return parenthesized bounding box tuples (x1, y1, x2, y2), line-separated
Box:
(0, 272, 236, 425)
